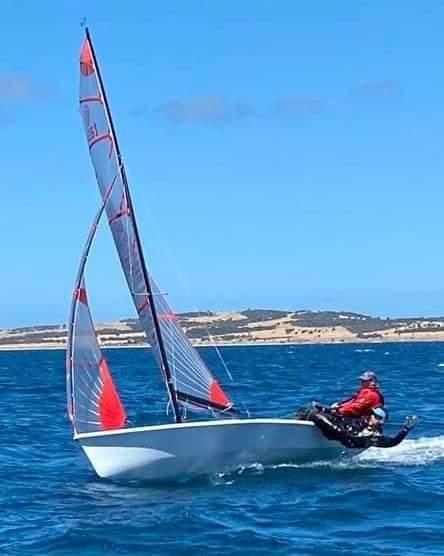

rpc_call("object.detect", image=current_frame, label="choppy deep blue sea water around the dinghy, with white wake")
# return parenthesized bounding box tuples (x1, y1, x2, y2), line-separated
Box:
(0, 343, 444, 556)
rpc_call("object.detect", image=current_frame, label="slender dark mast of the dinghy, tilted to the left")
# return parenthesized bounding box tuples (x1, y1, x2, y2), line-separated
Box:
(85, 27, 182, 423)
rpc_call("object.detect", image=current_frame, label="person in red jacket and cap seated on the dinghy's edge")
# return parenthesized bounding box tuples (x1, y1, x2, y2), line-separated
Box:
(332, 371, 384, 418)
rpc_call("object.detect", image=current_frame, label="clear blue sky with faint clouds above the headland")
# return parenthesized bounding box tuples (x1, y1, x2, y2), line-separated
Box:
(0, 1, 444, 327)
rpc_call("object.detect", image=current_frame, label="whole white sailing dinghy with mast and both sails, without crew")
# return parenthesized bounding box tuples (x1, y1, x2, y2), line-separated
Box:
(66, 29, 350, 481)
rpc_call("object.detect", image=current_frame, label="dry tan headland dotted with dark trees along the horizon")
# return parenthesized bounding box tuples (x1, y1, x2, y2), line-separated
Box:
(0, 309, 444, 350)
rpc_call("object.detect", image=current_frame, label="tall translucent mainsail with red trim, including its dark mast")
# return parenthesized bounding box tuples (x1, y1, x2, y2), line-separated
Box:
(76, 30, 235, 421)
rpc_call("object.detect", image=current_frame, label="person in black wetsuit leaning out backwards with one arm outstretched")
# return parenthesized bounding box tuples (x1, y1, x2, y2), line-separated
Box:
(310, 407, 418, 449)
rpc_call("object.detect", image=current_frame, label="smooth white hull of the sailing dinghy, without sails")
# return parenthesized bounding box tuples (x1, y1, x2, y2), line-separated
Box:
(75, 419, 354, 481)
